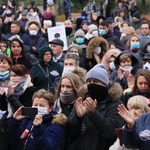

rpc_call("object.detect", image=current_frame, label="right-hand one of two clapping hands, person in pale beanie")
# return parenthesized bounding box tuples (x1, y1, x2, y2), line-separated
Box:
(85, 97, 97, 114)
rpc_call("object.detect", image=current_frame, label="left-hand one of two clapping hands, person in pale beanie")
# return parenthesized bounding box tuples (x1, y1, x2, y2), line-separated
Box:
(76, 97, 86, 118)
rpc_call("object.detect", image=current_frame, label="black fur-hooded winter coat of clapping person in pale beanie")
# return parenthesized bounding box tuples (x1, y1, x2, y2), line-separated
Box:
(67, 83, 123, 150)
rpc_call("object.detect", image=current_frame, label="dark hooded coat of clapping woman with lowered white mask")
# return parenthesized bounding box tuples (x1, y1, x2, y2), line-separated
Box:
(110, 50, 139, 89)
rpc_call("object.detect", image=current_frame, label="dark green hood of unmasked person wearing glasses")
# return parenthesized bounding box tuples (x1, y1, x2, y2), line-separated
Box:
(39, 45, 53, 63)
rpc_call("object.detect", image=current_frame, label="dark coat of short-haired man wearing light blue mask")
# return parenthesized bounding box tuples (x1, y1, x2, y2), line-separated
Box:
(102, 30, 125, 51)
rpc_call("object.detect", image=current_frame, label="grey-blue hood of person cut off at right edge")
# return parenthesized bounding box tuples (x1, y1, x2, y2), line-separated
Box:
(139, 36, 150, 57)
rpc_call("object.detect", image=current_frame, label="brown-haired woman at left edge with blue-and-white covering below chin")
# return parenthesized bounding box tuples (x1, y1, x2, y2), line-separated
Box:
(0, 55, 12, 87)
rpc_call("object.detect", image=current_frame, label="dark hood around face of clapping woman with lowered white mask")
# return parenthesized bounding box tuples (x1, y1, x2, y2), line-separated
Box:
(114, 50, 139, 68)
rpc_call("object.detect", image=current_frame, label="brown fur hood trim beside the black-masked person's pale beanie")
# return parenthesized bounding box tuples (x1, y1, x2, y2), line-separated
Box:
(108, 81, 123, 101)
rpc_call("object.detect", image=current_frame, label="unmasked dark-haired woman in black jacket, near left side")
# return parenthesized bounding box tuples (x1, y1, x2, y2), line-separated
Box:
(10, 36, 32, 70)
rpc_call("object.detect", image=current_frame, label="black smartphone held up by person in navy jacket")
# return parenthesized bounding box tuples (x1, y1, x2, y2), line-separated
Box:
(22, 107, 38, 117)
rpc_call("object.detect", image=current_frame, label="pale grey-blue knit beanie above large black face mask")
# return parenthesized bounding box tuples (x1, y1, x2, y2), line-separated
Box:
(86, 64, 109, 85)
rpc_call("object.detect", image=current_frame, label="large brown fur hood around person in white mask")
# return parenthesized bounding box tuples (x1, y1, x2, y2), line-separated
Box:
(86, 37, 109, 59)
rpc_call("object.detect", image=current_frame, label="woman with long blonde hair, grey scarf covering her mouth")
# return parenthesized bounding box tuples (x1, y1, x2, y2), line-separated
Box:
(54, 72, 81, 117)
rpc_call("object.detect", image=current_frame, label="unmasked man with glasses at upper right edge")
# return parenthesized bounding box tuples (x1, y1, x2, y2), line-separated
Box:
(140, 21, 150, 39)
